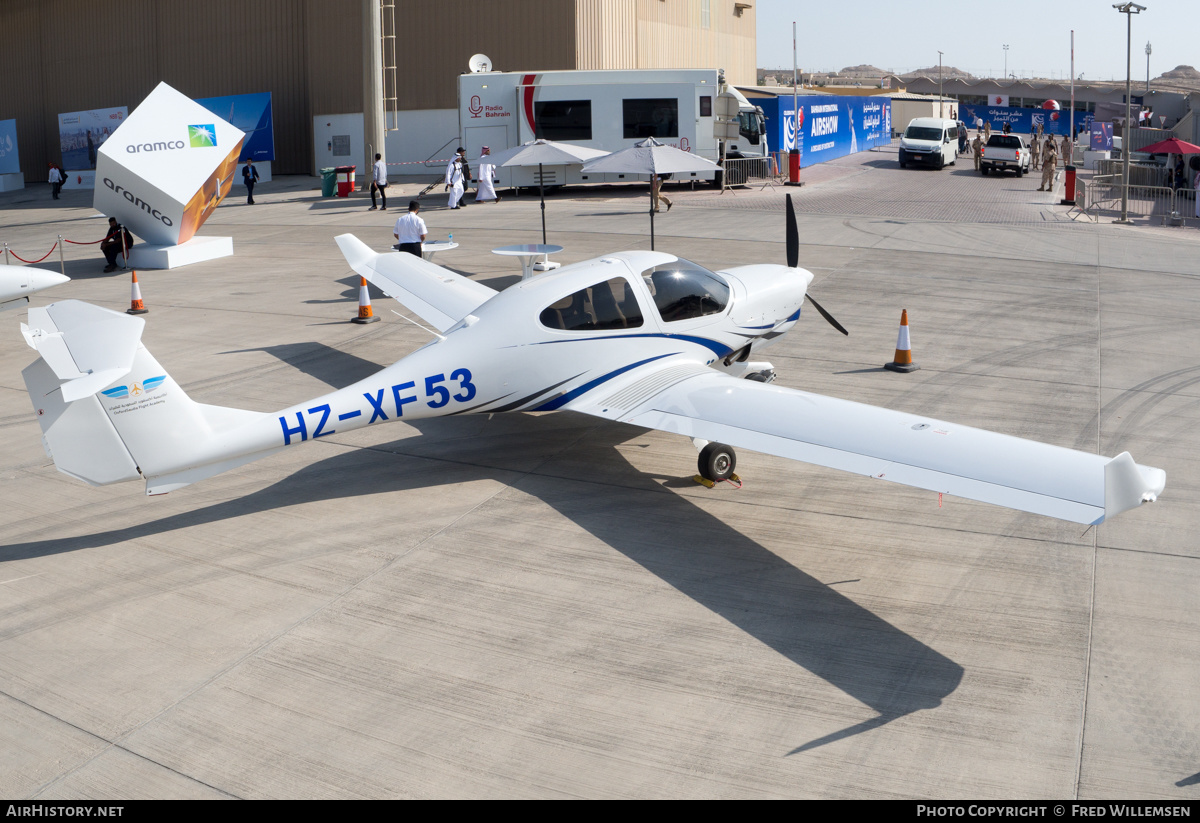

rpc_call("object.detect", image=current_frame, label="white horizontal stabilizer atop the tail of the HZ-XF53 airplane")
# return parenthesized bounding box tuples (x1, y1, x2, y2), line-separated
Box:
(20, 300, 145, 403)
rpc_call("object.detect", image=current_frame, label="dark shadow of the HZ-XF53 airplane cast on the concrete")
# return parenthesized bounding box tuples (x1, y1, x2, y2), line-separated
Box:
(0, 343, 964, 755)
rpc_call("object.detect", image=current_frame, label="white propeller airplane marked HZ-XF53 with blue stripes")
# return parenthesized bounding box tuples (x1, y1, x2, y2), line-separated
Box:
(23, 199, 1166, 523)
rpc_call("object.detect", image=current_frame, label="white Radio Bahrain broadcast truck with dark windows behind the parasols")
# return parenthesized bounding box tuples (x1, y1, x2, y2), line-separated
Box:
(458, 68, 769, 186)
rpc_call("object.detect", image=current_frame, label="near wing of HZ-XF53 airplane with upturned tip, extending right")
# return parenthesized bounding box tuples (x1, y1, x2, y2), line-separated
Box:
(566, 364, 1166, 523)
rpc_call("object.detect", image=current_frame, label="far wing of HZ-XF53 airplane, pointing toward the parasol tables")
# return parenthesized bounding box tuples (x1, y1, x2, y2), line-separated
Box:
(335, 234, 496, 331)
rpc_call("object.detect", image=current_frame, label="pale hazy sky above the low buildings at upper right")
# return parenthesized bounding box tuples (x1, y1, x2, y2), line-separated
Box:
(752, 0, 1200, 83)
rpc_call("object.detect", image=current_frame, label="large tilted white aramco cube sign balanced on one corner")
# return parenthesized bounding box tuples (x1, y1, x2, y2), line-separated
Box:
(92, 83, 246, 246)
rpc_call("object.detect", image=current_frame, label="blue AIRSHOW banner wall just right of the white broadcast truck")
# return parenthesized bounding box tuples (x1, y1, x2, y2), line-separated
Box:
(754, 95, 892, 166)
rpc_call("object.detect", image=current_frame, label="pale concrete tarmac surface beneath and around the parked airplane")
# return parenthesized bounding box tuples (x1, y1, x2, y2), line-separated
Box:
(0, 151, 1200, 801)
